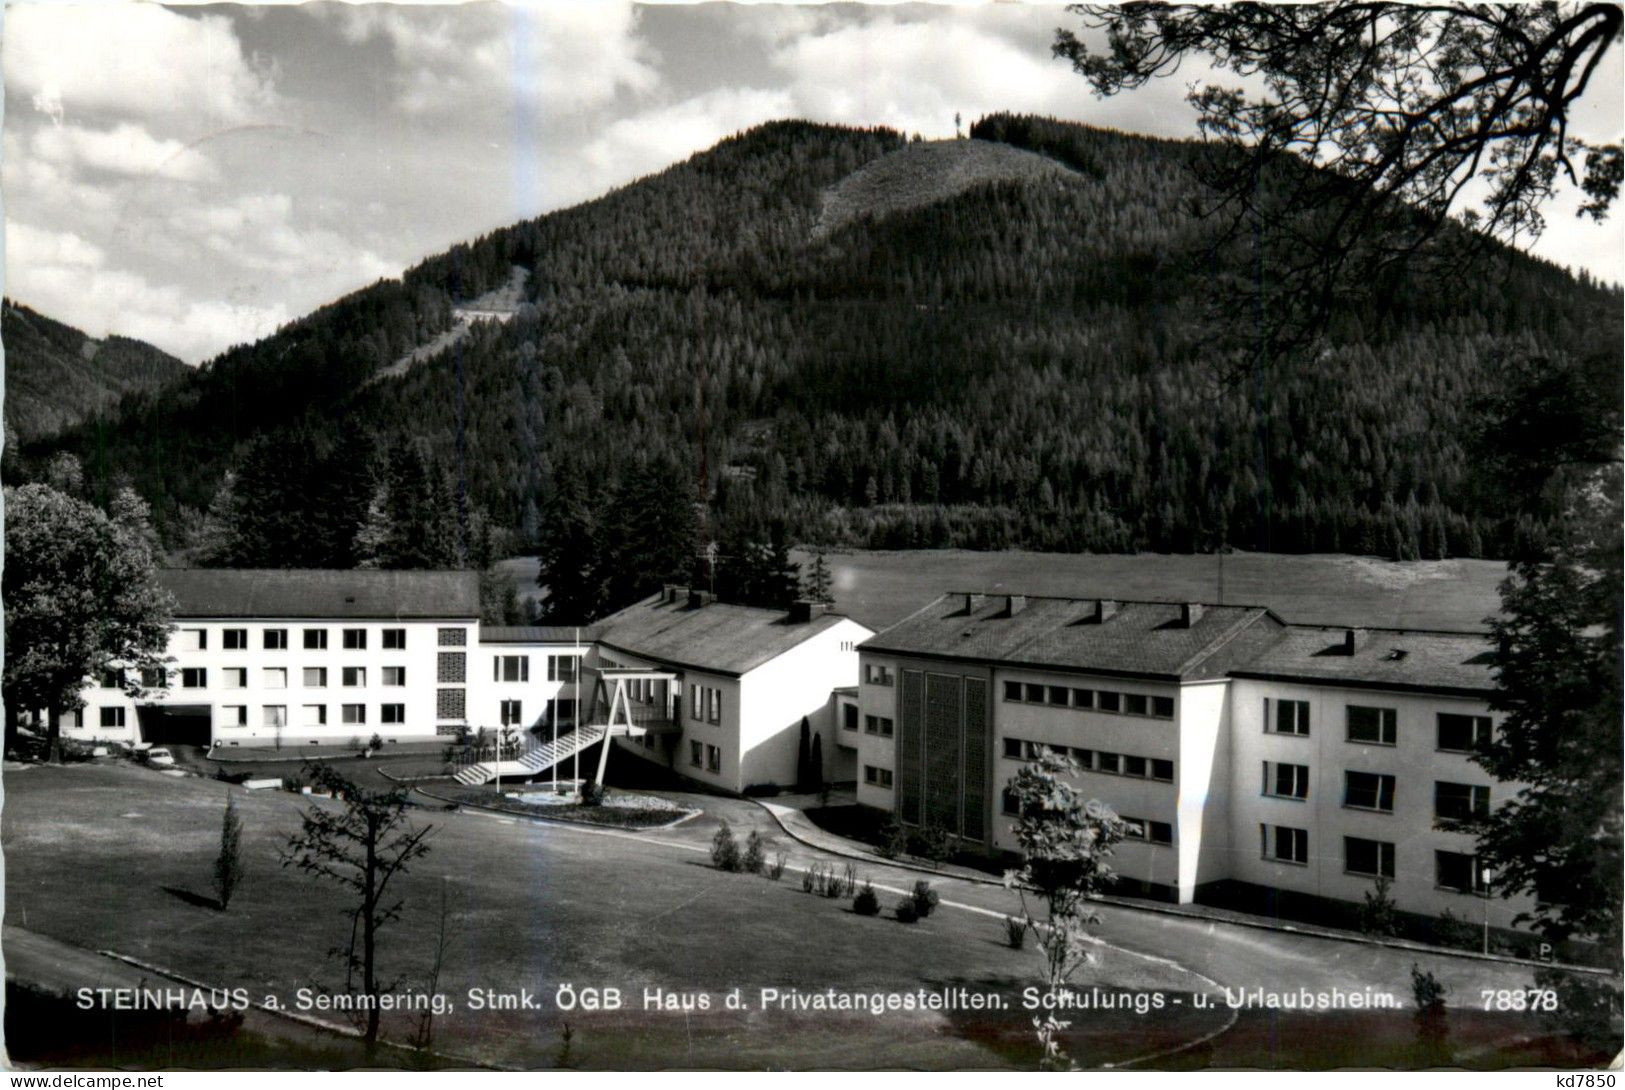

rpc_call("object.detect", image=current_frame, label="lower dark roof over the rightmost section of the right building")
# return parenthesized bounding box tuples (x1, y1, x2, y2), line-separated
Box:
(1230, 625, 1495, 695)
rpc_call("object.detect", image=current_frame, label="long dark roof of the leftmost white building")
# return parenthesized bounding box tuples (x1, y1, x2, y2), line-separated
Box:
(159, 569, 479, 621)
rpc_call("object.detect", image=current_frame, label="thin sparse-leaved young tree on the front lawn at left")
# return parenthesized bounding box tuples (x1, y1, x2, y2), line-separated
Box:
(281, 762, 434, 1053)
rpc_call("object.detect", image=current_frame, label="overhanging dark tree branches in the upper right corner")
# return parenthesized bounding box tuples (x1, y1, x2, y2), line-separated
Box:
(1055, 0, 1625, 349)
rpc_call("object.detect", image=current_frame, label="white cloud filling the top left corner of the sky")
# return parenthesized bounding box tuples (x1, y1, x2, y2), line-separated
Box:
(0, 3, 275, 128)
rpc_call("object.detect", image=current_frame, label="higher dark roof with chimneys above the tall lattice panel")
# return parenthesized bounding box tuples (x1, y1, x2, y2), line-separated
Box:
(861, 593, 1284, 681)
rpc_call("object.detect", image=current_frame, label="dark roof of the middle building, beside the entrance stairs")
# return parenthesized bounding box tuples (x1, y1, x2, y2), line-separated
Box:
(595, 595, 871, 676)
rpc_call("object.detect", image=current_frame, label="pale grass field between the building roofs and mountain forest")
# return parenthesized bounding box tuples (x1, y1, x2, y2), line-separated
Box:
(502, 549, 1506, 630)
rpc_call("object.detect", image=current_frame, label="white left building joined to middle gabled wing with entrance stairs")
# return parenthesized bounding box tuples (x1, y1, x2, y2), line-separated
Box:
(63, 569, 873, 791)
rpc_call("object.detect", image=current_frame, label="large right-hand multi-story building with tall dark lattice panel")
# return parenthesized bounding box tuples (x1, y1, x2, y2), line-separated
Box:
(855, 593, 1528, 926)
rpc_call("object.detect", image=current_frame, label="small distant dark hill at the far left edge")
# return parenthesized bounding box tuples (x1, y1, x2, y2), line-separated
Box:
(0, 299, 189, 447)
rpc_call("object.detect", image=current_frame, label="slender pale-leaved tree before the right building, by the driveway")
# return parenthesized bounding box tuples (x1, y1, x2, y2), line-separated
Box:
(1004, 754, 1123, 1071)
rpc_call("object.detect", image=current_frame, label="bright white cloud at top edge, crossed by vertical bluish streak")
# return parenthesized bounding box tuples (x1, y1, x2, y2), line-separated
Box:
(333, 0, 658, 114)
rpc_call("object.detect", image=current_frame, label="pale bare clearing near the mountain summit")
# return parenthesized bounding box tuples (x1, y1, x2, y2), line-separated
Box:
(813, 140, 1082, 237)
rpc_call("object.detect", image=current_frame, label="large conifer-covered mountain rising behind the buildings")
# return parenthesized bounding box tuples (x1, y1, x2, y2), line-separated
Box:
(18, 115, 1622, 578)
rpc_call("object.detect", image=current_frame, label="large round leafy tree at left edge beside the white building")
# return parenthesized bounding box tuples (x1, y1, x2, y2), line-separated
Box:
(3, 484, 174, 760)
